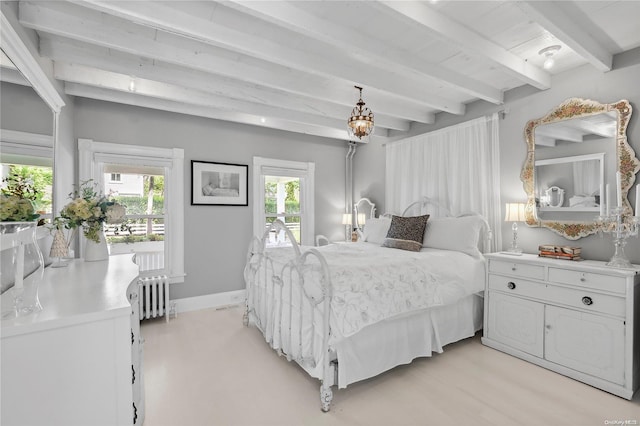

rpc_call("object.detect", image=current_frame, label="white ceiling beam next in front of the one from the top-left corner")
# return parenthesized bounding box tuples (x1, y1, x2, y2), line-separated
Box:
(65, 0, 465, 115)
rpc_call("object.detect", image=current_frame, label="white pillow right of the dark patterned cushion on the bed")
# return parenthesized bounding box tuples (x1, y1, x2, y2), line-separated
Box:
(422, 216, 484, 257)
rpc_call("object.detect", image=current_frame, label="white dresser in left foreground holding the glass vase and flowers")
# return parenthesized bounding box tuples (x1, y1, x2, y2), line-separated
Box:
(0, 255, 144, 426)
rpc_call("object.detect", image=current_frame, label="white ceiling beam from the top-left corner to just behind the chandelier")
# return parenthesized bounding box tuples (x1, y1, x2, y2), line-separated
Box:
(20, 3, 435, 123)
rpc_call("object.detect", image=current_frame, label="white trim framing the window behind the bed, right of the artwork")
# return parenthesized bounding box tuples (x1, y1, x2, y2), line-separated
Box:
(253, 157, 316, 246)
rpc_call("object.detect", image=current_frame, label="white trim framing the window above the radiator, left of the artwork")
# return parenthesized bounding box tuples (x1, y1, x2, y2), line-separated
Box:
(78, 139, 185, 283)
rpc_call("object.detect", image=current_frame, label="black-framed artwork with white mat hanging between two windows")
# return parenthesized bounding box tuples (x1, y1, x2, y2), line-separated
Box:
(191, 160, 249, 206)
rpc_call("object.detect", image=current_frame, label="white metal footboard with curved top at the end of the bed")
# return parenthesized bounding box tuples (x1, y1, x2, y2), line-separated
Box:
(243, 220, 335, 412)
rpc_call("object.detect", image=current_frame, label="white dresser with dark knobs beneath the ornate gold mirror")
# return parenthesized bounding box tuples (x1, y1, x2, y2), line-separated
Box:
(482, 253, 640, 399)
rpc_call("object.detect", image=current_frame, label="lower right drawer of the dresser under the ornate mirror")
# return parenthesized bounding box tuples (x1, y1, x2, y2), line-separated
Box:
(546, 285, 626, 317)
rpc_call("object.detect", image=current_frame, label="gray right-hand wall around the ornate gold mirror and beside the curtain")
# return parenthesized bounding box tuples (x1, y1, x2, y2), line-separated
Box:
(354, 53, 640, 263)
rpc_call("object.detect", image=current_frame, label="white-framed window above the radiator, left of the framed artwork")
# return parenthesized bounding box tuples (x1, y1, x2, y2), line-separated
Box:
(78, 139, 184, 282)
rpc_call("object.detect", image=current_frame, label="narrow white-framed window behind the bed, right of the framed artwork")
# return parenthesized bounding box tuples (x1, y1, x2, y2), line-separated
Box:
(253, 157, 315, 245)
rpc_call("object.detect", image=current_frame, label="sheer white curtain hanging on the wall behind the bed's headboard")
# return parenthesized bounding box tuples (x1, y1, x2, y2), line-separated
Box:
(385, 114, 502, 251)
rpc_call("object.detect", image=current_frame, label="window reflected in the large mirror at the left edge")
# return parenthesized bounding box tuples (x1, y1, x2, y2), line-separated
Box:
(0, 129, 53, 223)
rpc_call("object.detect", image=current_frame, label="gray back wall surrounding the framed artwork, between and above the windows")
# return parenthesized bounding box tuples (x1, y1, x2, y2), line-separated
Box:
(74, 98, 347, 298)
